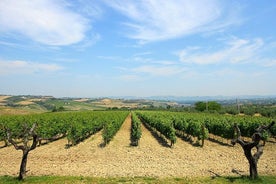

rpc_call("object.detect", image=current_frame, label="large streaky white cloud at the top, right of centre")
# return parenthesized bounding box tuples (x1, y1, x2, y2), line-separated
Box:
(105, 0, 237, 42)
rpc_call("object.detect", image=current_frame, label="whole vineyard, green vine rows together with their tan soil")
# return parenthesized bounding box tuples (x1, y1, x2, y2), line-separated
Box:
(0, 111, 276, 177)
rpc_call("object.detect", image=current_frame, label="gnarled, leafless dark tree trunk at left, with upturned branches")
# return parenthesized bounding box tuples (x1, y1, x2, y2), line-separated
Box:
(6, 123, 38, 180)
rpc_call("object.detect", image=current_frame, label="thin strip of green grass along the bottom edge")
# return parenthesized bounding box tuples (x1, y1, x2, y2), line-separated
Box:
(0, 176, 276, 184)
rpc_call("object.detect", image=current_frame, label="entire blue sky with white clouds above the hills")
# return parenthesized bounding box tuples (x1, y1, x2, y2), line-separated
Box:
(0, 0, 276, 97)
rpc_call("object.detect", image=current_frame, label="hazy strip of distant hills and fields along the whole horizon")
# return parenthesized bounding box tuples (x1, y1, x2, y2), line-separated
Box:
(0, 95, 276, 114)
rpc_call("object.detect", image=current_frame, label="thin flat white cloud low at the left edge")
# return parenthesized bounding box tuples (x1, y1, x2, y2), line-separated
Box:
(0, 60, 63, 75)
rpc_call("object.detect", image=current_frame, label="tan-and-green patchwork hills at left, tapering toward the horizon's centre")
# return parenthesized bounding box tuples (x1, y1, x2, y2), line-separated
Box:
(0, 95, 178, 114)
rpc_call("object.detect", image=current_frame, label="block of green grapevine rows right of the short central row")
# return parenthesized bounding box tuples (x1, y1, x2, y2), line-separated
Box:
(135, 111, 276, 145)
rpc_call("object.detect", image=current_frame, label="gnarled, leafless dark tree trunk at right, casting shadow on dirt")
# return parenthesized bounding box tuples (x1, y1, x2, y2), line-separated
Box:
(231, 121, 275, 179)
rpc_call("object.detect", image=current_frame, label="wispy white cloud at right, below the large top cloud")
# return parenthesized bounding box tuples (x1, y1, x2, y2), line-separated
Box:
(179, 38, 264, 64)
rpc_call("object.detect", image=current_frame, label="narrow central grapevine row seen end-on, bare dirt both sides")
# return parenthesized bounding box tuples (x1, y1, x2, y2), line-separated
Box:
(131, 112, 142, 146)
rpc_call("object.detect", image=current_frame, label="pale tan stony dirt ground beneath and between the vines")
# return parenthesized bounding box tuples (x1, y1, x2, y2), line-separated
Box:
(0, 116, 276, 177)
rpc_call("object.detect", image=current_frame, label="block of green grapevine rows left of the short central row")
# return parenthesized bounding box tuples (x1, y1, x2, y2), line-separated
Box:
(0, 111, 129, 145)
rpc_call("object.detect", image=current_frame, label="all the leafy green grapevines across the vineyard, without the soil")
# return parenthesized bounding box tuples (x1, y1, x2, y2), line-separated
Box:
(0, 111, 276, 148)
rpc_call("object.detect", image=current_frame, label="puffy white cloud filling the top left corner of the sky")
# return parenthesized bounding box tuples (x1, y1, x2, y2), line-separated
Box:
(0, 0, 89, 46)
